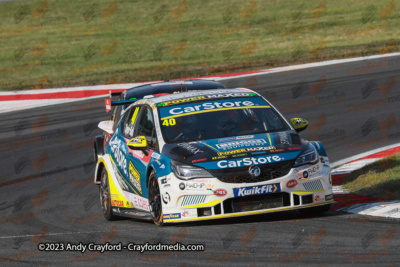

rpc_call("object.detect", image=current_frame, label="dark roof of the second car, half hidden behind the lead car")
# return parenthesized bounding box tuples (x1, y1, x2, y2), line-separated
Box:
(123, 80, 225, 100)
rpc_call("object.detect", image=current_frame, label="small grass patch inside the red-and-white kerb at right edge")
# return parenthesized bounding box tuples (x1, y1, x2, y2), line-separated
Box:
(343, 153, 400, 200)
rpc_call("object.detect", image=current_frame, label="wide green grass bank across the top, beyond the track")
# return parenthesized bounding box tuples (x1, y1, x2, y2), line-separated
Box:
(0, 0, 400, 90)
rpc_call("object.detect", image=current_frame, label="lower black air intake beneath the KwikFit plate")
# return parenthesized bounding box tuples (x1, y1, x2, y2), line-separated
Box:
(223, 192, 290, 214)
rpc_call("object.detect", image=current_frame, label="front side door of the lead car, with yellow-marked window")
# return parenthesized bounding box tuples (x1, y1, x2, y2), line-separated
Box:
(121, 106, 156, 198)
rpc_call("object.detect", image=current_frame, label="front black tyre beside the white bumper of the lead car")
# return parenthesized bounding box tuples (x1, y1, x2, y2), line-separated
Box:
(148, 172, 164, 226)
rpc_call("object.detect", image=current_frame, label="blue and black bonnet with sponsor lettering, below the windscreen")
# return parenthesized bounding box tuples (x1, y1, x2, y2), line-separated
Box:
(162, 131, 308, 169)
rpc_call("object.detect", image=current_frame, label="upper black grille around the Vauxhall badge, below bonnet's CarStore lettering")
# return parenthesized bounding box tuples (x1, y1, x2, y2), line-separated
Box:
(209, 160, 294, 183)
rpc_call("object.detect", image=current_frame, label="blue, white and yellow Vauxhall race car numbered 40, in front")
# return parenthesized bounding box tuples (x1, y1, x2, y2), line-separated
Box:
(95, 88, 334, 225)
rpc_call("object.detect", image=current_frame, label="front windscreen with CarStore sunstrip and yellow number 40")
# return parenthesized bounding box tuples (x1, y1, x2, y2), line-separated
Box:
(158, 94, 290, 143)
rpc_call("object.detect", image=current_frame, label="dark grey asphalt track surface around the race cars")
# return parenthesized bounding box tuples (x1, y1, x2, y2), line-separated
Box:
(0, 58, 400, 266)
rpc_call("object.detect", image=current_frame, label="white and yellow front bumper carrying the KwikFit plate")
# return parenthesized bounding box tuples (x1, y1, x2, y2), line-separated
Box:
(159, 163, 334, 223)
